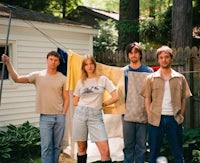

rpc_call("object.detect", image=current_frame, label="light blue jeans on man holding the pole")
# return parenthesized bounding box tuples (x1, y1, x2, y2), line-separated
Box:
(40, 114, 65, 163)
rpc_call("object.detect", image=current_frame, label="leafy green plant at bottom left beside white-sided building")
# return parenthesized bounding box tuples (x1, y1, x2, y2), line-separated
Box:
(0, 121, 40, 163)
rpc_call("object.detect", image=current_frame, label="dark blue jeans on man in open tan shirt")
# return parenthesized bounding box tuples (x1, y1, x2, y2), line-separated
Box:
(148, 115, 184, 163)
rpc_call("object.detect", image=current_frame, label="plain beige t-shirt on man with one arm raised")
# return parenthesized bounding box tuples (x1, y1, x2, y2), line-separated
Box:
(28, 70, 66, 114)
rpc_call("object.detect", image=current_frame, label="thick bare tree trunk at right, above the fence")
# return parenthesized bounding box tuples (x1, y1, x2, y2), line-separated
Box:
(172, 0, 192, 48)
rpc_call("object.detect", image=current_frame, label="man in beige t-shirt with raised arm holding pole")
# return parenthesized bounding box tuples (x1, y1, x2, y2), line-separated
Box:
(2, 51, 69, 163)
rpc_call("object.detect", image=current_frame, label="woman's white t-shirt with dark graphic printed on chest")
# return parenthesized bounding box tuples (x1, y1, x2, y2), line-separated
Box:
(73, 76, 116, 110)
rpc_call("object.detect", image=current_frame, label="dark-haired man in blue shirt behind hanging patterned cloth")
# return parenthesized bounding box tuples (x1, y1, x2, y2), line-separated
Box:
(122, 42, 153, 163)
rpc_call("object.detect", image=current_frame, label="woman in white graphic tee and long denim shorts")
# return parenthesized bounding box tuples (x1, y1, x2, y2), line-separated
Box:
(72, 55, 119, 163)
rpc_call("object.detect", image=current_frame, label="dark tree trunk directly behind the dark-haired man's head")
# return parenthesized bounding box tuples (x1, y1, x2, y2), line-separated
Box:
(118, 0, 139, 62)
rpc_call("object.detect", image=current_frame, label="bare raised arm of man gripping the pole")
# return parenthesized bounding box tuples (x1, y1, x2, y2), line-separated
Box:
(1, 54, 29, 83)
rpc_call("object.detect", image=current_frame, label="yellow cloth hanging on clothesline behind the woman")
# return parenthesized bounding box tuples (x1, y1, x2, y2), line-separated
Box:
(67, 50, 125, 114)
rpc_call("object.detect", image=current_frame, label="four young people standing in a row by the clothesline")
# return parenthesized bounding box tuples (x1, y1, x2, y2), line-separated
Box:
(2, 42, 191, 163)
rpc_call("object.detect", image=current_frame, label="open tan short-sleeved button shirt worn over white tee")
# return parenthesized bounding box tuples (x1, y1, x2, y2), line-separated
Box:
(141, 69, 192, 126)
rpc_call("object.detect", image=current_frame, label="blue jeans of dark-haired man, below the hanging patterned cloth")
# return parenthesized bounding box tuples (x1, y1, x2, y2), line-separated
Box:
(122, 116, 147, 163)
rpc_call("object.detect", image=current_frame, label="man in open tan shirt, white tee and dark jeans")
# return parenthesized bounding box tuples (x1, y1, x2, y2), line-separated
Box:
(141, 46, 192, 163)
